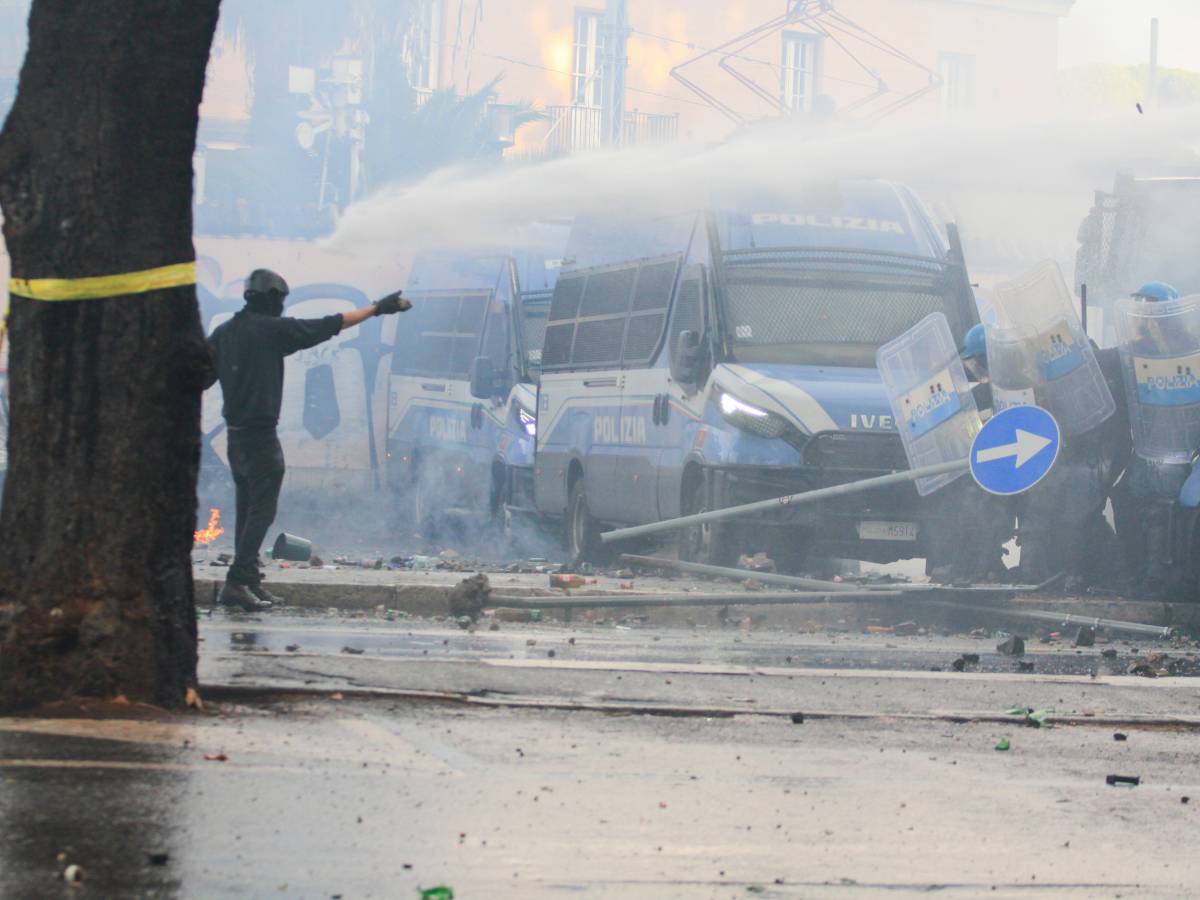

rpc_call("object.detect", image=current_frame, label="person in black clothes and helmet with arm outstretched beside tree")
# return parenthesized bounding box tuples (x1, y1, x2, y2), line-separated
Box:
(205, 269, 412, 612)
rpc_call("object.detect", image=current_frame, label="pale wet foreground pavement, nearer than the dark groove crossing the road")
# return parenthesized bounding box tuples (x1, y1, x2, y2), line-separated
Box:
(0, 698, 1200, 898)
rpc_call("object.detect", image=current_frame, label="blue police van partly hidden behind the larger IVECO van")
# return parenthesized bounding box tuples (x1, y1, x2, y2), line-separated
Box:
(386, 222, 569, 534)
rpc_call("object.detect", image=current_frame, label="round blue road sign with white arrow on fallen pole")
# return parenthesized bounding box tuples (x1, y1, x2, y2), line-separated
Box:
(971, 407, 1062, 496)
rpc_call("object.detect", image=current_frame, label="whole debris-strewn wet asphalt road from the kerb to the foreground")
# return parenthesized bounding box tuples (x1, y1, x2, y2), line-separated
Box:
(0, 613, 1200, 898)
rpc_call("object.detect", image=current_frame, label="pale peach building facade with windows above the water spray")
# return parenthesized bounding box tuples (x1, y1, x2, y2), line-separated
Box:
(420, 0, 1074, 156)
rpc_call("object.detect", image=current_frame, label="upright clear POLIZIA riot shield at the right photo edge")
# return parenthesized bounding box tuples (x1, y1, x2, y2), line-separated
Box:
(1115, 295, 1200, 463)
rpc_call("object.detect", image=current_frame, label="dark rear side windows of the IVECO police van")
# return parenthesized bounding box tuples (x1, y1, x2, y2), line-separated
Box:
(541, 256, 679, 371)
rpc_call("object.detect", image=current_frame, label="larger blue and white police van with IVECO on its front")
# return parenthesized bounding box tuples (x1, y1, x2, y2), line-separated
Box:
(534, 180, 978, 563)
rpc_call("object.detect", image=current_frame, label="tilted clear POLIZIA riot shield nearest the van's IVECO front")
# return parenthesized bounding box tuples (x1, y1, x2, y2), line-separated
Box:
(875, 312, 983, 497)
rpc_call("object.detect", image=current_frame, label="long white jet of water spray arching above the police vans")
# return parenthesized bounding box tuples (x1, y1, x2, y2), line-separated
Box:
(330, 109, 1200, 273)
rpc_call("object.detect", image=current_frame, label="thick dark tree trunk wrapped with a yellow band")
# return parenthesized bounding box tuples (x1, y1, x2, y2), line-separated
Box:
(0, 0, 220, 709)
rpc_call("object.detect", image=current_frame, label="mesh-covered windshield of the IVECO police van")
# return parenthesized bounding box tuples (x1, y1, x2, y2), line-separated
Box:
(720, 250, 968, 367)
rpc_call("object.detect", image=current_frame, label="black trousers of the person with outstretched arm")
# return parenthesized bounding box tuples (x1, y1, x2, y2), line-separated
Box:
(226, 426, 284, 586)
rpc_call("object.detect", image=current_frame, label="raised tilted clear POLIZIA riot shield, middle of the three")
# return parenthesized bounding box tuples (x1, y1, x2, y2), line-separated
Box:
(988, 260, 1116, 434)
